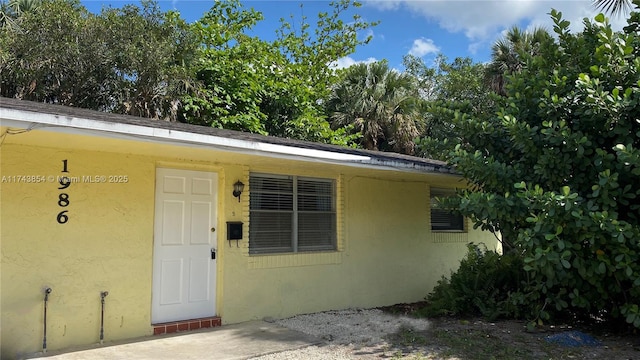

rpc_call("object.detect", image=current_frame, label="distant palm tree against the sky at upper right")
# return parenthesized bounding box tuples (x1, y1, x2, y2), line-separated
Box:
(485, 26, 552, 95)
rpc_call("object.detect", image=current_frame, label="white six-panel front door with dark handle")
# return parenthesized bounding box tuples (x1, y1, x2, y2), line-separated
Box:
(151, 168, 218, 324)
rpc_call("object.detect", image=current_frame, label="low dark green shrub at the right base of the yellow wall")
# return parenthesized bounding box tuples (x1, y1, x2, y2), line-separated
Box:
(416, 243, 526, 320)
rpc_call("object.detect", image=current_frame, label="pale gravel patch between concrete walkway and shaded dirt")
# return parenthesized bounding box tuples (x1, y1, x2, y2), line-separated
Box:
(254, 309, 430, 360)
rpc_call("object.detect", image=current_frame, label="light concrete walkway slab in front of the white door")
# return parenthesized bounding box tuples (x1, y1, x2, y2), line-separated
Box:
(27, 321, 320, 360)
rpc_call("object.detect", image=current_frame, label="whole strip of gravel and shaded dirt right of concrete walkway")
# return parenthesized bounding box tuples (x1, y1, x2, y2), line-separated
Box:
(254, 304, 640, 360)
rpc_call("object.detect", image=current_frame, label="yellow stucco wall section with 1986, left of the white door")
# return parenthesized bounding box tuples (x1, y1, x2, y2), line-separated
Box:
(1, 144, 154, 358)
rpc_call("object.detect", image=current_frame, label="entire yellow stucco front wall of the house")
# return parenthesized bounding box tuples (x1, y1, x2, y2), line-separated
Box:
(0, 129, 495, 359)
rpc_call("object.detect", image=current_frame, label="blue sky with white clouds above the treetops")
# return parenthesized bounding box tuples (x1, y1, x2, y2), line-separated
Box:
(82, 0, 625, 69)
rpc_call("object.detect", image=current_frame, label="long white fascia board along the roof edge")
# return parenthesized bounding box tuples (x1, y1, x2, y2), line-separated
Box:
(0, 108, 450, 173)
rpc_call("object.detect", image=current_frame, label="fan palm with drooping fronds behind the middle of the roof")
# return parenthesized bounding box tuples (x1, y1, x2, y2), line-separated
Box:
(327, 61, 420, 154)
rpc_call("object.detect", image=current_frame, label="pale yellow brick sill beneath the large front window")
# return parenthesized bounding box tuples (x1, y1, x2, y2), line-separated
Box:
(248, 250, 342, 269)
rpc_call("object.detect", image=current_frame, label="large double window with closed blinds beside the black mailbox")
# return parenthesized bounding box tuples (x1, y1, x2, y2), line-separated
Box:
(249, 174, 336, 254)
